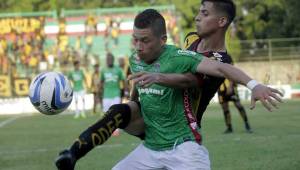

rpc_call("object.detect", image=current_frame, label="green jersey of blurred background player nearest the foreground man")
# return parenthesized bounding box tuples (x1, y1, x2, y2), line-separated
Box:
(101, 66, 124, 98)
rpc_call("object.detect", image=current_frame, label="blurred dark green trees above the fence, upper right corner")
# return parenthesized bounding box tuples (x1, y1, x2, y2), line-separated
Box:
(237, 0, 300, 39)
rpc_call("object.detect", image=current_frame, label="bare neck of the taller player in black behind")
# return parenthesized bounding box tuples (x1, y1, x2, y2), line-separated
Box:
(197, 34, 226, 53)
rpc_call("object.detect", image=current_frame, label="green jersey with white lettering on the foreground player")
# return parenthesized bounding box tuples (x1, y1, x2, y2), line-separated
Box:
(129, 45, 202, 150)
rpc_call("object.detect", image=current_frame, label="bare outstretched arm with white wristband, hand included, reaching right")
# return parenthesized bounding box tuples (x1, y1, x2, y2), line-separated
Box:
(197, 58, 283, 111)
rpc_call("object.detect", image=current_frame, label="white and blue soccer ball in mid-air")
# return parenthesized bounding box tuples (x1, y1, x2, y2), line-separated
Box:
(29, 72, 73, 115)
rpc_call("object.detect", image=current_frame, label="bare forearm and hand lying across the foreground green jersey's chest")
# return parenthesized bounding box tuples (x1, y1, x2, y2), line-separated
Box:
(128, 72, 199, 88)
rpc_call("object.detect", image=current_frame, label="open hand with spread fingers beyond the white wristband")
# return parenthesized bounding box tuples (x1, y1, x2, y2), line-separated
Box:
(250, 84, 283, 112)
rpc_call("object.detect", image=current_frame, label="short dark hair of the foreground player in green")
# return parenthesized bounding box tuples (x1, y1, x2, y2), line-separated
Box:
(134, 9, 167, 37)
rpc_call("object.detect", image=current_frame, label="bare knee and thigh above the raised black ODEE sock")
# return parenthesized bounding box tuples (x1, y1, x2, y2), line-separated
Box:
(124, 101, 145, 135)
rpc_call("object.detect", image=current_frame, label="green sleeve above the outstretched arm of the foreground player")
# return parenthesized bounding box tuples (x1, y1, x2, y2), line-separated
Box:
(171, 50, 203, 73)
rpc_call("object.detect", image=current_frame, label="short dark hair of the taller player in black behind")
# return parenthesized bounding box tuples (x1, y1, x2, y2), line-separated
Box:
(201, 0, 236, 25)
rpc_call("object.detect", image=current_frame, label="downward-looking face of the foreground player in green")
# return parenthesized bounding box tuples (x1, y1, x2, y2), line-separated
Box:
(132, 27, 166, 63)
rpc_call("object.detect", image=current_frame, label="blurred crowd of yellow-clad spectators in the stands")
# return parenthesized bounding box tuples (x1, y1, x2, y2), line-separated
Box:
(0, 14, 179, 78)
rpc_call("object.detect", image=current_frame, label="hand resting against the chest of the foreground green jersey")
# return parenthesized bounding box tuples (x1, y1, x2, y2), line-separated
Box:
(128, 72, 159, 88)
